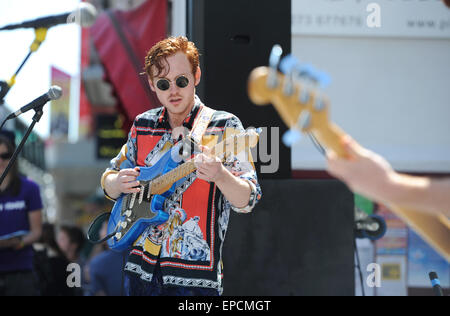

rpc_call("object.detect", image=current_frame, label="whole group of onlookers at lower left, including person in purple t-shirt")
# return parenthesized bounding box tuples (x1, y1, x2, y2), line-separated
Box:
(0, 131, 123, 296)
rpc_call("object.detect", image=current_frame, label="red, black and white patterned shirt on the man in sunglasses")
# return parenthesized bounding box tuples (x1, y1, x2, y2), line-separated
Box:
(102, 96, 261, 293)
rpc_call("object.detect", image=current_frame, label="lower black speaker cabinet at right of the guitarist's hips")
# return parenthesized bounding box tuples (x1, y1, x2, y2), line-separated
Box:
(223, 180, 355, 296)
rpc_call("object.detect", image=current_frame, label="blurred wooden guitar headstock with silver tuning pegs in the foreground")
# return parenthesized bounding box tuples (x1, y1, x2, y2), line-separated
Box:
(248, 45, 343, 155)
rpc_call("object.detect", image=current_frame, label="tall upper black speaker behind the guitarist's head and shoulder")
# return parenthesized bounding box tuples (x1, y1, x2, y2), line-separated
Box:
(187, 0, 291, 179)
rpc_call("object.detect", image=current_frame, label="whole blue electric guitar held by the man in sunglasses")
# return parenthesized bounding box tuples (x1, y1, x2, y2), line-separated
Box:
(99, 129, 261, 251)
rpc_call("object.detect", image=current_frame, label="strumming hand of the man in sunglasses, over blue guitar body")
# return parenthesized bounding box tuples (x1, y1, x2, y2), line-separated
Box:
(104, 167, 139, 199)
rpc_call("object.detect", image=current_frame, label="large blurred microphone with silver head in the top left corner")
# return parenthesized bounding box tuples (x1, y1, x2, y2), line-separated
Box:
(0, 2, 97, 31)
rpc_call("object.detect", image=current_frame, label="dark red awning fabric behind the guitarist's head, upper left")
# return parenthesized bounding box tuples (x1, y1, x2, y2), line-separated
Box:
(90, 0, 167, 130)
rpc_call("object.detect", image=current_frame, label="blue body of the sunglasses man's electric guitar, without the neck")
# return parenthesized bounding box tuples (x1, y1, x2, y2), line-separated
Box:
(107, 146, 184, 251)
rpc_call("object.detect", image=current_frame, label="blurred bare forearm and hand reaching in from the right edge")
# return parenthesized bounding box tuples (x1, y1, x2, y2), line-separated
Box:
(327, 135, 450, 216)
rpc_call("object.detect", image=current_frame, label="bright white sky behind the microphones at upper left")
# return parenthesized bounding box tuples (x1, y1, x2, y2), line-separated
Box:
(0, 0, 81, 138)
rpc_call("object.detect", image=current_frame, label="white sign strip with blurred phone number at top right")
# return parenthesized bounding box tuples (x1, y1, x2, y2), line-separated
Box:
(292, 0, 450, 39)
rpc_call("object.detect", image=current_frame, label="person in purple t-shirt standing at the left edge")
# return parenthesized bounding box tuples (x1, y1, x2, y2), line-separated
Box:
(0, 132, 42, 296)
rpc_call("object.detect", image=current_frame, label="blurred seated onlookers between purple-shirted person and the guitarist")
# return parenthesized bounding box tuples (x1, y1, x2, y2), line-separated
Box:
(34, 223, 123, 296)
